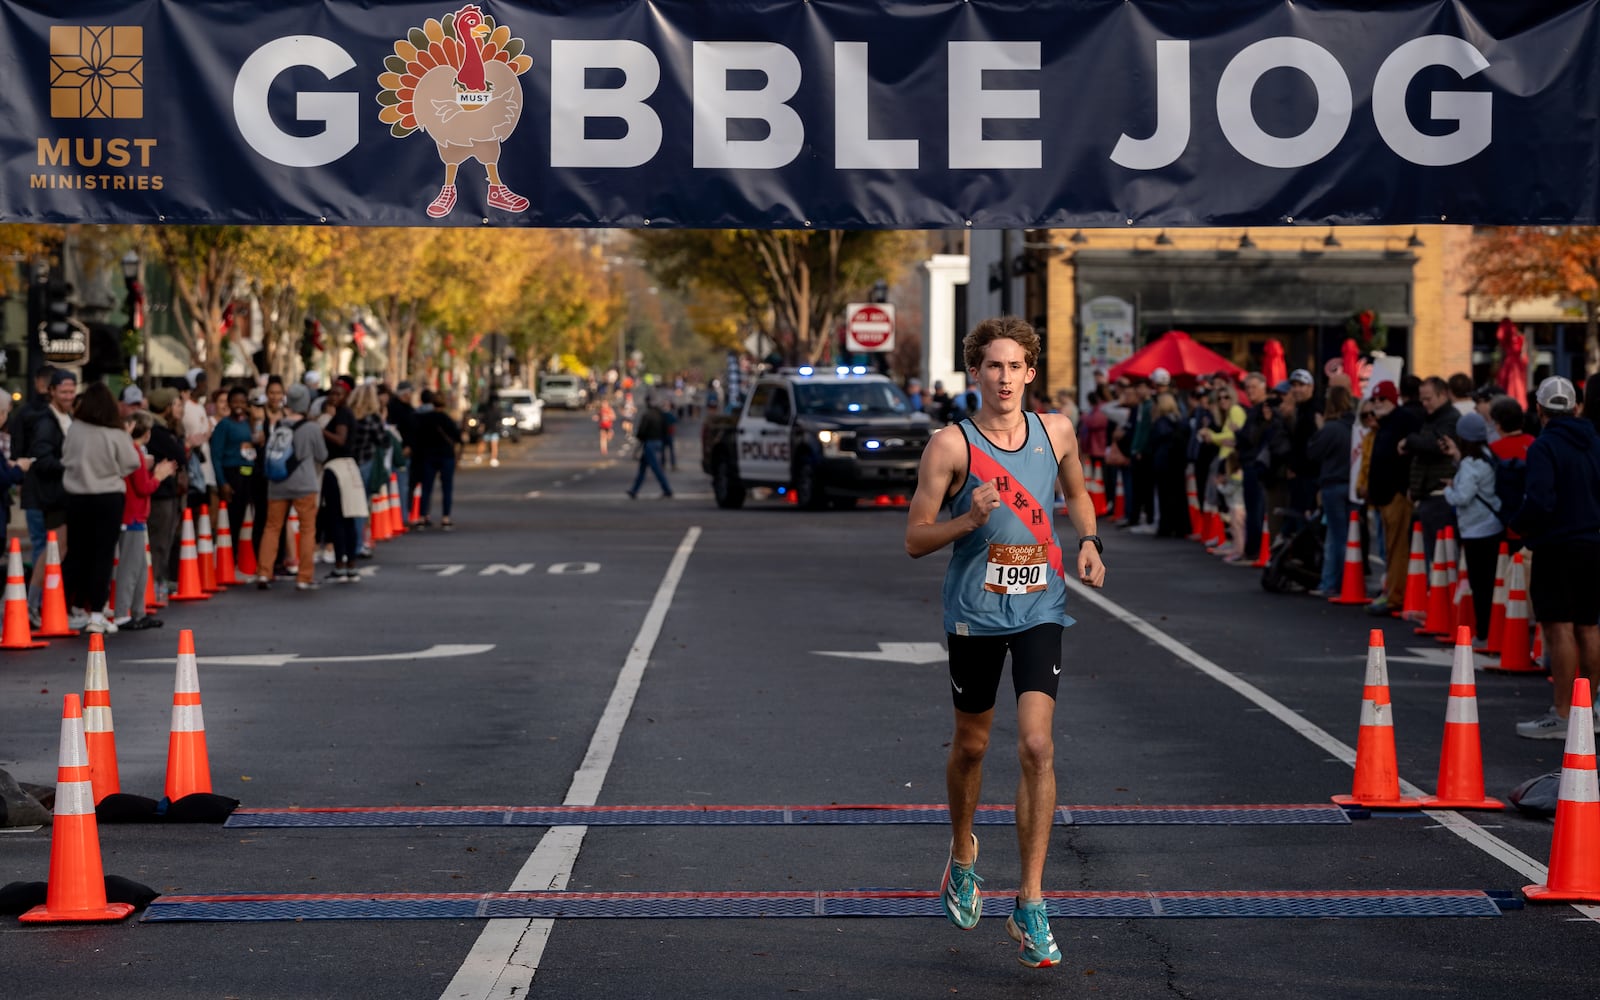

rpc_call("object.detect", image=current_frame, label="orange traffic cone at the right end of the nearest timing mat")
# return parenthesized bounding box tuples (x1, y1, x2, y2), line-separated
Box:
(1522, 677, 1600, 902)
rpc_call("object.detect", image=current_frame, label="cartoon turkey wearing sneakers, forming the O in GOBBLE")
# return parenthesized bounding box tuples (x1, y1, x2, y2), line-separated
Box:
(378, 3, 533, 219)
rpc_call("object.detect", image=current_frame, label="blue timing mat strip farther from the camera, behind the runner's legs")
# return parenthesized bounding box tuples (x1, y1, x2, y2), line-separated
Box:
(224, 803, 1365, 827)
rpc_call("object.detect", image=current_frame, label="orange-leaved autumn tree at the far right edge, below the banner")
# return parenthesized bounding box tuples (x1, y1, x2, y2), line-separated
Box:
(1467, 226, 1600, 371)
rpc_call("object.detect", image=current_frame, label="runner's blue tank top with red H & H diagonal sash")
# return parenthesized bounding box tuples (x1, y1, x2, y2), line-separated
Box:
(944, 413, 1077, 635)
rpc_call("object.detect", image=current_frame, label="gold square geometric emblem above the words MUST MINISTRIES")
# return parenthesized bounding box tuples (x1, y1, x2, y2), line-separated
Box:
(50, 24, 144, 118)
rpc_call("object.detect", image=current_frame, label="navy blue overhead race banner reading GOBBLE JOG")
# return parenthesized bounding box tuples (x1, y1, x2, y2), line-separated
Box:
(0, 0, 1600, 229)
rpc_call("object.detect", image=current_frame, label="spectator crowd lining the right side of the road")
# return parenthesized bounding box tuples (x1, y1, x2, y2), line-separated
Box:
(1077, 358, 1600, 739)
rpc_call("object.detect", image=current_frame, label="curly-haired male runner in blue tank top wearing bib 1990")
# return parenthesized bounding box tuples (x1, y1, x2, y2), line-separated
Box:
(906, 317, 1106, 968)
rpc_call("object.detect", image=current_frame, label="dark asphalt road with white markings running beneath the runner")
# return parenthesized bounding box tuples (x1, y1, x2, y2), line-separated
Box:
(0, 413, 1600, 998)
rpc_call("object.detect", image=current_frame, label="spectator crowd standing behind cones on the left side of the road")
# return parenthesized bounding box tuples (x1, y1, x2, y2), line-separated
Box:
(0, 365, 462, 634)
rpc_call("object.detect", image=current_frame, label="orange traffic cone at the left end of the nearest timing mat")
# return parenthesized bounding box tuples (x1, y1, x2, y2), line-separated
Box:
(21, 694, 133, 923)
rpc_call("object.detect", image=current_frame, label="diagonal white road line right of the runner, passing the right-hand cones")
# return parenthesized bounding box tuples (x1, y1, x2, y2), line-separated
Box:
(1067, 578, 1600, 922)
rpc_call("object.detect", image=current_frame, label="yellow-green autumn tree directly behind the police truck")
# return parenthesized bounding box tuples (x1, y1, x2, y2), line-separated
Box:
(635, 229, 910, 362)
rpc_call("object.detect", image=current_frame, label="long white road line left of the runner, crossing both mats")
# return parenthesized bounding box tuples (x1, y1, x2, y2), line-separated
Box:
(440, 526, 701, 1000)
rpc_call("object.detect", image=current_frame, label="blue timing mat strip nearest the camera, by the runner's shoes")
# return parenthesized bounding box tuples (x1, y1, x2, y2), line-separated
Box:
(144, 890, 1515, 923)
